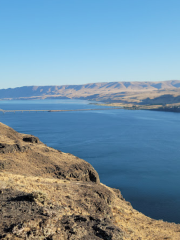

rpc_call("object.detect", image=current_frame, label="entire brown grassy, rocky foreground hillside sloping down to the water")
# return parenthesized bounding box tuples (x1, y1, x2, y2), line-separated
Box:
(0, 123, 180, 240)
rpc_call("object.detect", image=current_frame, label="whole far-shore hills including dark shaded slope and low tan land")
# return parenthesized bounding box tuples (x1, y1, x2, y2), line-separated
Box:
(0, 80, 180, 105)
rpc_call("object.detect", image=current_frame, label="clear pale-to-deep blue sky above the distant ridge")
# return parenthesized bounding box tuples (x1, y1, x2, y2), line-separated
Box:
(0, 0, 180, 88)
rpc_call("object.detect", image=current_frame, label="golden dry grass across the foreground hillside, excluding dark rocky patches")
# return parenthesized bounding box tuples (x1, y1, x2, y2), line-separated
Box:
(0, 124, 180, 240)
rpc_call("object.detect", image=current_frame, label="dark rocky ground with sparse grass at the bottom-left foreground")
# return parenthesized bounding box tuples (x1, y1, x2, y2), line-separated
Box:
(0, 189, 126, 240)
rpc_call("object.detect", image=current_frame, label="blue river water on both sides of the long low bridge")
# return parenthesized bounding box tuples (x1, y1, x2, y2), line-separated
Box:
(0, 100, 180, 223)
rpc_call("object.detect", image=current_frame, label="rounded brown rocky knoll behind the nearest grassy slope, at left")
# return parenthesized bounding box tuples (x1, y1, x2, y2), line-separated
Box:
(0, 124, 99, 183)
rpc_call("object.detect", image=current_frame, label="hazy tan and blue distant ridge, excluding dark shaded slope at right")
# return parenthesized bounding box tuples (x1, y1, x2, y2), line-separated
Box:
(0, 80, 180, 104)
